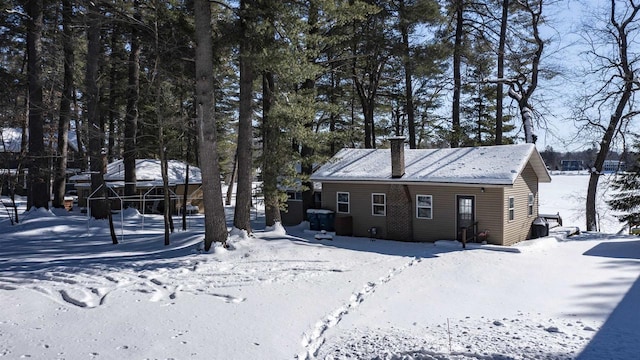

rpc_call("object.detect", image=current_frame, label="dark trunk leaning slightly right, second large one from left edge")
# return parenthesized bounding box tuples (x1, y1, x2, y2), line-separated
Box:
(53, 0, 75, 208)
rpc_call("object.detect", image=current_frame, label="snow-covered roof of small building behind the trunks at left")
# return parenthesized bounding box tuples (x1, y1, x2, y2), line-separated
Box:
(70, 159, 202, 185)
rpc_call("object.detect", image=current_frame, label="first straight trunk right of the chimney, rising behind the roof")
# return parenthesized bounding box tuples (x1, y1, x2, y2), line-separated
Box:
(450, 0, 465, 148)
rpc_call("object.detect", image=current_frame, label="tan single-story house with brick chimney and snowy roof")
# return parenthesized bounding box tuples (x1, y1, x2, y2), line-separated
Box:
(311, 138, 551, 245)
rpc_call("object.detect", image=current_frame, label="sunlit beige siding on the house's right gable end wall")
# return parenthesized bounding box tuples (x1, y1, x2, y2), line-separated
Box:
(503, 164, 539, 245)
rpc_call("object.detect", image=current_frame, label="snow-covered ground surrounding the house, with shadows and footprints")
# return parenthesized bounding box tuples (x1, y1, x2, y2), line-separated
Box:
(0, 174, 640, 360)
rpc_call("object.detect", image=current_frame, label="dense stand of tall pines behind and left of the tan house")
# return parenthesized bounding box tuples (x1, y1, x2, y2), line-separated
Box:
(0, 0, 636, 241)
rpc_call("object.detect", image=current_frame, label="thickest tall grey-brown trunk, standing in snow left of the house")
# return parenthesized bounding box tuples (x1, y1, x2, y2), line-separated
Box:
(194, 0, 228, 251)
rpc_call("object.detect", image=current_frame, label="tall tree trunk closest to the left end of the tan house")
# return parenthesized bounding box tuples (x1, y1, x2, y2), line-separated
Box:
(262, 71, 282, 226)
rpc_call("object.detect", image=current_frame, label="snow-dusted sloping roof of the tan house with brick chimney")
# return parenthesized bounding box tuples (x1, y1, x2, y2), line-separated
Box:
(311, 144, 551, 185)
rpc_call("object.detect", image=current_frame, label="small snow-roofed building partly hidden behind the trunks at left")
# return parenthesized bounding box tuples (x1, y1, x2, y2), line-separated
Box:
(69, 159, 204, 213)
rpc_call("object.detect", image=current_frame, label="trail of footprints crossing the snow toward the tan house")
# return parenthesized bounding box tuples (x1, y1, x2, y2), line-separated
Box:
(296, 258, 422, 360)
